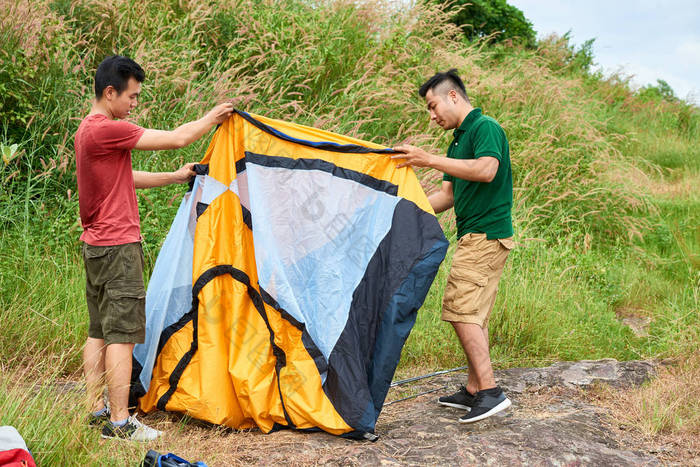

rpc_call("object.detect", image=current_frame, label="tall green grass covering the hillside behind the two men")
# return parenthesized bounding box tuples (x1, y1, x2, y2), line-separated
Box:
(0, 0, 698, 368)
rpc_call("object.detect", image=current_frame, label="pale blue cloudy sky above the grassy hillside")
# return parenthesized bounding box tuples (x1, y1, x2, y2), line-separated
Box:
(507, 0, 700, 105)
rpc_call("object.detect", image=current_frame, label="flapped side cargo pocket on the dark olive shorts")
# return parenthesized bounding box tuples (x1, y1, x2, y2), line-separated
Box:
(106, 281, 146, 333)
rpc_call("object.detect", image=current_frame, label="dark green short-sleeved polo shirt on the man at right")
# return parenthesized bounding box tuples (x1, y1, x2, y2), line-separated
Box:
(443, 108, 513, 239)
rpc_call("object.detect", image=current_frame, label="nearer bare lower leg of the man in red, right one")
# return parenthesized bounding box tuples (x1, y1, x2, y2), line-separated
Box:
(105, 344, 134, 422)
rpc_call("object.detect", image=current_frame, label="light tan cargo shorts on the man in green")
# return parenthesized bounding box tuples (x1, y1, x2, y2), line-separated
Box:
(442, 233, 515, 328)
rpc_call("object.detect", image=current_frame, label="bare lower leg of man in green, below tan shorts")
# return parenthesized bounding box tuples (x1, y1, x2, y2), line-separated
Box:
(452, 322, 496, 394)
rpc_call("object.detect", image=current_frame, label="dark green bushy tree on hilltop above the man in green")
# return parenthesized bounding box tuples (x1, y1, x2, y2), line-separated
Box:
(437, 0, 535, 47)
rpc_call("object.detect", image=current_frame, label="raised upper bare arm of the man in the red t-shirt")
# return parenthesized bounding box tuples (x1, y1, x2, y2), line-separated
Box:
(134, 103, 233, 151)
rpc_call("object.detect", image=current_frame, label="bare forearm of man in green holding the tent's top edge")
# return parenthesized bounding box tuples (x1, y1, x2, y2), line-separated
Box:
(391, 145, 499, 183)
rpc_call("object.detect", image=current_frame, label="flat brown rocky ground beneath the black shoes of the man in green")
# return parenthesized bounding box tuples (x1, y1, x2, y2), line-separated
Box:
(189, 360, 660, 466)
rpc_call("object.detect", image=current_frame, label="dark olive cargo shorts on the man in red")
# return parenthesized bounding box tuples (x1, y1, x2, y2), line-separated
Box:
(83, 243, 146, 345)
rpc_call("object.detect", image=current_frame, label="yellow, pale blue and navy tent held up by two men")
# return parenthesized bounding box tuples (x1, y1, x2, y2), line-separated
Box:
(132, 111, 448, 437)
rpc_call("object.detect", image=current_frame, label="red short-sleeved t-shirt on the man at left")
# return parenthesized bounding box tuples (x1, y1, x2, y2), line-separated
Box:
(75, 114, 145, 246)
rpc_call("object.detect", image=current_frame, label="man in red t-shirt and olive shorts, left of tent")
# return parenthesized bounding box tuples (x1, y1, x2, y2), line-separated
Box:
(75, 55, 233, 441)
